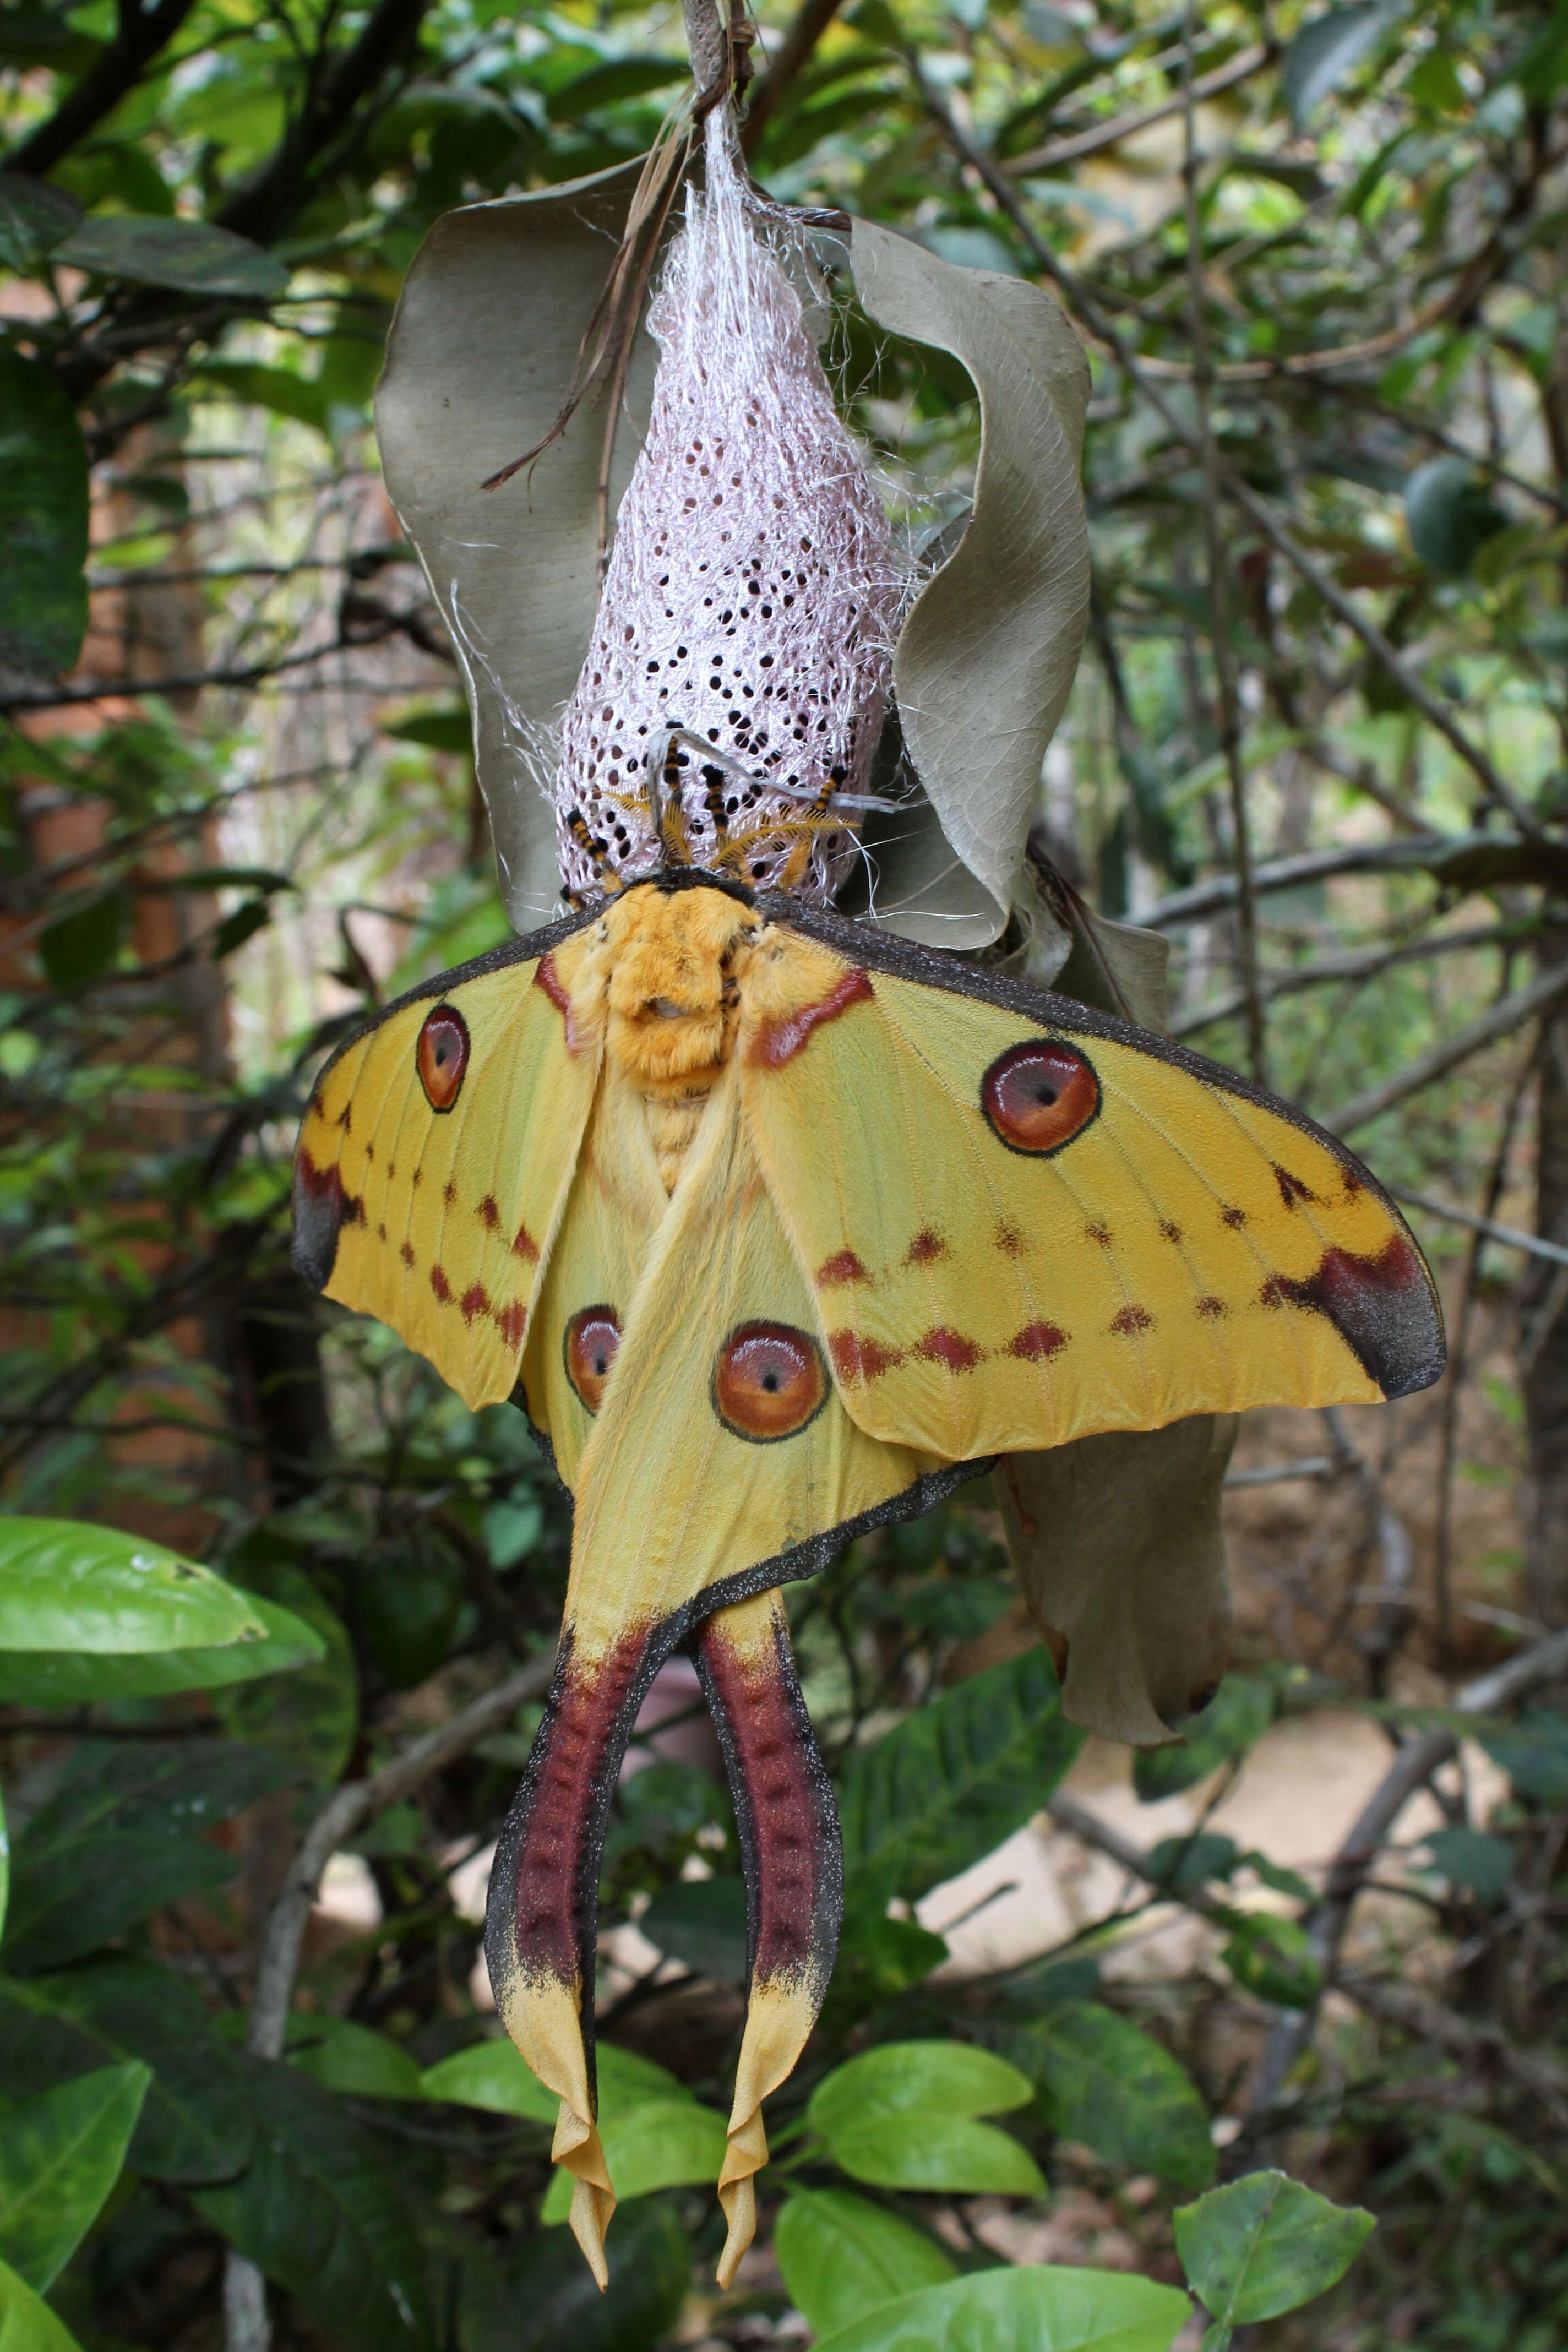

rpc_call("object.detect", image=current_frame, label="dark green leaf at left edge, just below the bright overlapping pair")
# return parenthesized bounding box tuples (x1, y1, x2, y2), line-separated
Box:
(5, 1740, 287, 1971)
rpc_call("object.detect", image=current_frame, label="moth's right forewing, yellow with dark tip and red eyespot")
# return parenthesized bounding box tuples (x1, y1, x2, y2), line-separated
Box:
(741, 922, 1444, 1458)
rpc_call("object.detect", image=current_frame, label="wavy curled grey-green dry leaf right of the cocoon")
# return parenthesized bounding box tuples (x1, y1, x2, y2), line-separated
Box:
(851, 219, 1088, 948)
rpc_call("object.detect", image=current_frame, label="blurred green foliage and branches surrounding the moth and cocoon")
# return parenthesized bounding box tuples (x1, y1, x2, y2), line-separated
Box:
(0, 0, 1568, 2352)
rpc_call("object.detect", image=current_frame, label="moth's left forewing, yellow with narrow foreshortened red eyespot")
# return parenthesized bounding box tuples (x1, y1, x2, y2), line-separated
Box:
(294, 934, 597, 1407)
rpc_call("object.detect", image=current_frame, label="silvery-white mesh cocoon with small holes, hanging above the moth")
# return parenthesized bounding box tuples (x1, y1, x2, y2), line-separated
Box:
(555, 113, 900, 906)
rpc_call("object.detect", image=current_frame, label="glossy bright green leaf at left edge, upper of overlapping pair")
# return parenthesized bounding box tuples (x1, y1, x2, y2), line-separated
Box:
(0, 1520, 268, 1653)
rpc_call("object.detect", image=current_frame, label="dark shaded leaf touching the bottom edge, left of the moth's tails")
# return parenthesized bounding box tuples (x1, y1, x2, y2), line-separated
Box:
(195, 2065, 433, 2352)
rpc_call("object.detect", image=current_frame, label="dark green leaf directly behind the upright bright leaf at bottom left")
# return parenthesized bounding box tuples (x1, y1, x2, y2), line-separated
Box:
(0, 1959, 256, 2182)
